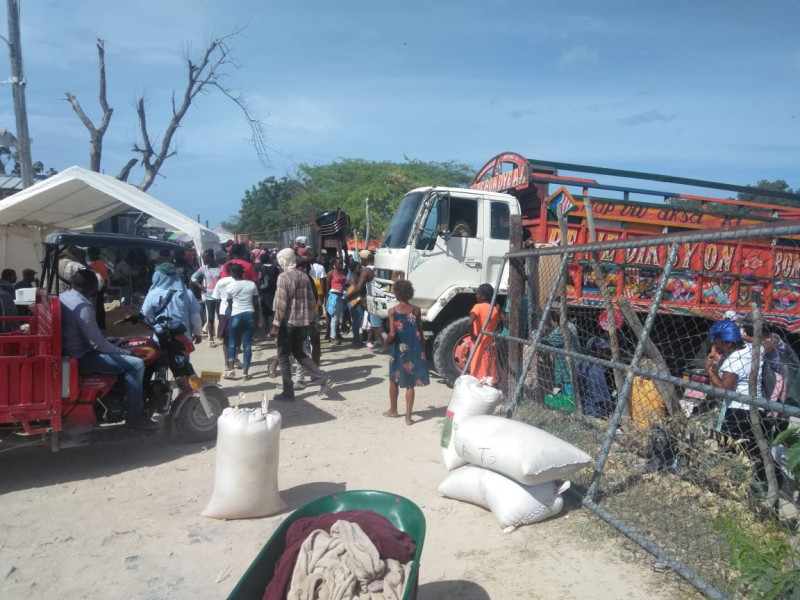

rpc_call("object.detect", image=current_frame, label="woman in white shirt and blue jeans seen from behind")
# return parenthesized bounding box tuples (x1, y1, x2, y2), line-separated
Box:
(224, 263, 258, 381)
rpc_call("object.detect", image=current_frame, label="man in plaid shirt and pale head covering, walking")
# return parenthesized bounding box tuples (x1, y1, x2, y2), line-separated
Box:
(270, 248, 333, 401)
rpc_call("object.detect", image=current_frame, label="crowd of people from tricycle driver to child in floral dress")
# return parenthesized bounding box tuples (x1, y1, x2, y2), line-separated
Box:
(39, 236, 429, 428)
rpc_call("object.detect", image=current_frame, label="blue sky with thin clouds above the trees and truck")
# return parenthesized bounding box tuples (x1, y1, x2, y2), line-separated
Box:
(0, 0, 800, 227)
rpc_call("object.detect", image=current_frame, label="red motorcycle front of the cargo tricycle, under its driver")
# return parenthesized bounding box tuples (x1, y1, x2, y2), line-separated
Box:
(72, 313, 228, 442)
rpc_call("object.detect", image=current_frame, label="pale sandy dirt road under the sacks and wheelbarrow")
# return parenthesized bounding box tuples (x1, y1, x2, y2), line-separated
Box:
(0, 336, 682, 600)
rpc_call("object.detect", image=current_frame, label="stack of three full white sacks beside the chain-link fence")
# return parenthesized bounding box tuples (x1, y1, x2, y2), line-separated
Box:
(439, 376, 592, 532)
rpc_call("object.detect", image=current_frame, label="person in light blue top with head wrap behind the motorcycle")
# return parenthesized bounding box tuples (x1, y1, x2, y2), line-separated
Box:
(142, 262, 203, 344)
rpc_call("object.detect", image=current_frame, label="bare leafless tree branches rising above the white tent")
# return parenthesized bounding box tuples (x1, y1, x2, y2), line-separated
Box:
(66, 29, 268, 191)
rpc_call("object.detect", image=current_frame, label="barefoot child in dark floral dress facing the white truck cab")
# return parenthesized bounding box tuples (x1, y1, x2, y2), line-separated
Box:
(383, 279, 430, 425)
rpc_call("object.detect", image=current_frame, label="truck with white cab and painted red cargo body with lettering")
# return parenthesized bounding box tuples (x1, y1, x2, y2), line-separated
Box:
(367, 152, 800, 383)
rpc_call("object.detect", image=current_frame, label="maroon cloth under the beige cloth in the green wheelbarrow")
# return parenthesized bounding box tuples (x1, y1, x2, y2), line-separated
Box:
(263, 510, 417, 600)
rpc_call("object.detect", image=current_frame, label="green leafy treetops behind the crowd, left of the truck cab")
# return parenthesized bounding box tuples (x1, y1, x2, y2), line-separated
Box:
(235, 159, 473, 237)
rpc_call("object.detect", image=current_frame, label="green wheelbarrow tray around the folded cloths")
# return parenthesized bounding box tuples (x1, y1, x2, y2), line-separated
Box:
(228, 490, 425, 600)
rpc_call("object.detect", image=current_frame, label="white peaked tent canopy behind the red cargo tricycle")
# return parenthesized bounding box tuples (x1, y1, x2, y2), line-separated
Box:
(0, 167, 219, 272)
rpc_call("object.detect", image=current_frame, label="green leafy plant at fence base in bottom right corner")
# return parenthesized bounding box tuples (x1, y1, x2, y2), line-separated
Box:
(714, 517, 800, 600)
